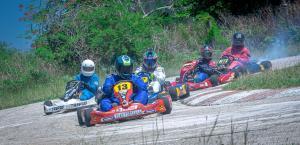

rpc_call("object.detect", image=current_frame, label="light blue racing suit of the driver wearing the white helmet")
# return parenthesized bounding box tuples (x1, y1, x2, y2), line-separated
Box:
(75, 73, 99, 100)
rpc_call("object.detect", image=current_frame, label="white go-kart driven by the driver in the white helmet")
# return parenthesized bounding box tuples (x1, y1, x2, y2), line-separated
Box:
(44, 80, 96, 115)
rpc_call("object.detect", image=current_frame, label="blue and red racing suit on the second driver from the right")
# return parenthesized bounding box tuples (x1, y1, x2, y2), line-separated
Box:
(194, 58, 216, 83)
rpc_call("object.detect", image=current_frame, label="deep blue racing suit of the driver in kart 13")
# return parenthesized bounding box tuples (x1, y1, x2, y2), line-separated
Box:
(100, 74, 148, 112)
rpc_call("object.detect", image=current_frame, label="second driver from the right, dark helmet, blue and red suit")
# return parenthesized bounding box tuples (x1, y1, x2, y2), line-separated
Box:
(194, 45, 216, 83)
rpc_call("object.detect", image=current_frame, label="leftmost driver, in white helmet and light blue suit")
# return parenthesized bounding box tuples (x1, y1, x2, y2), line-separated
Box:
(75, 59, 99, 100)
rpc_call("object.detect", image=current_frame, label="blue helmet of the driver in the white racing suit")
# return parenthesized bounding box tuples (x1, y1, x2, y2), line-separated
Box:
(143, 48, 157, 71)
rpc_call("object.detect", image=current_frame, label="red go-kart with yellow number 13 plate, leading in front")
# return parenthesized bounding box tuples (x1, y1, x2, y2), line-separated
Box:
(77, 80, 172, 127)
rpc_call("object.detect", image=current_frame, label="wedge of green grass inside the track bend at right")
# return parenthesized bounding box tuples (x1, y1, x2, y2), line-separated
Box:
(225, 64, 300, 90)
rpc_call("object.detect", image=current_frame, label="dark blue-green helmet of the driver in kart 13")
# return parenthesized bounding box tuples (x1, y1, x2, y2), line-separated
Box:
(115, 55, 133, 79)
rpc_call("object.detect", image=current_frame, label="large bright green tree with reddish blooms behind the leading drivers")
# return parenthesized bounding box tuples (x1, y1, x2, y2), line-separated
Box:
(20, 1, 161, 67)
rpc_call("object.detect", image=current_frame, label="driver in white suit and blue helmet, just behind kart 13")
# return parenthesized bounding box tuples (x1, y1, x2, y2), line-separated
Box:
(135, 48, 166, 93)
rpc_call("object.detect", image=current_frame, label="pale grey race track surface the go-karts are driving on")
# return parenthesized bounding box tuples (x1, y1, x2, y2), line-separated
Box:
(0, 56, 300, 145)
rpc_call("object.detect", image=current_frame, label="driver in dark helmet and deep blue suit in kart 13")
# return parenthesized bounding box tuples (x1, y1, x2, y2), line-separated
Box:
(100, 55, 148, 112)
